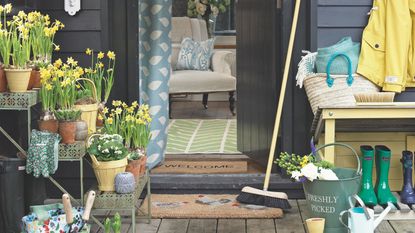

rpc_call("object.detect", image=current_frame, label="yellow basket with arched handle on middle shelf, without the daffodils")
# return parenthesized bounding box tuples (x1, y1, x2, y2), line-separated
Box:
(74, 78, 98, 134)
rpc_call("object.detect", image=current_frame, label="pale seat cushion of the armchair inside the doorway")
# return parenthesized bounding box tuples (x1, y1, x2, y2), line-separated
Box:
(170, 70, 236, 94)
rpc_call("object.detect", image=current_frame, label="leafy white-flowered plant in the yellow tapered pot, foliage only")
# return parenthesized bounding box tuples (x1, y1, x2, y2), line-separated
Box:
(88, 134, 129, 162)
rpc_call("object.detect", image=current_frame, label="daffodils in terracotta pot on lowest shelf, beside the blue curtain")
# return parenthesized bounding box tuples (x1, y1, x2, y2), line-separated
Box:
(103, 100, 151, 179)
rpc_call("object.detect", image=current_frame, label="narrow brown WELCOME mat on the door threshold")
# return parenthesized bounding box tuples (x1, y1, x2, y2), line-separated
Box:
(152, 160, 248, 174)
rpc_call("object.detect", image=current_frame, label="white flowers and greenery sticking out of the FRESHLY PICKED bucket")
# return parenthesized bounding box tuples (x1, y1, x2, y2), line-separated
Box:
(275, 152, 338, 182)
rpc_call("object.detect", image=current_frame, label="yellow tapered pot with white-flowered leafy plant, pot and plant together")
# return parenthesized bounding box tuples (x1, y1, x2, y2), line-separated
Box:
(88, 134, 128, 191)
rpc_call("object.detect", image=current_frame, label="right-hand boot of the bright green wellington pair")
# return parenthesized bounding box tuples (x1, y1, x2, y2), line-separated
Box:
(375, 146, 397, 206)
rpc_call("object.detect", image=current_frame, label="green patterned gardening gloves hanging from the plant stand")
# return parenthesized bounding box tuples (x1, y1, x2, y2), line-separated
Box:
(26, 129, 61, 177)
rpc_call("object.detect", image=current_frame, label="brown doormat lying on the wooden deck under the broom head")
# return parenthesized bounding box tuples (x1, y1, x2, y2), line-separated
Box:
(141, 194, 283, 219)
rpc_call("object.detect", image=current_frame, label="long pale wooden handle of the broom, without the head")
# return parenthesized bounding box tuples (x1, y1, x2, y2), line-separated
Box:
(264, 0, 301, 191)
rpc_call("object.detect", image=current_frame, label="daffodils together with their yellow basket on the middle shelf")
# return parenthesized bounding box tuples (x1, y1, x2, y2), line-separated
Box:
(80, 48, 115, 132)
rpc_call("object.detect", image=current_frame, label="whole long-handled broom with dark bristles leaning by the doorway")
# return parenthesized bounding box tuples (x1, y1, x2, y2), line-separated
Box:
(236, 0, 301, 209)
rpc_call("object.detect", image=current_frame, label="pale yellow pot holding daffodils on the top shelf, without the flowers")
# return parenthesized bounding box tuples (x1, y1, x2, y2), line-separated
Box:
(4, 69, 32, 92)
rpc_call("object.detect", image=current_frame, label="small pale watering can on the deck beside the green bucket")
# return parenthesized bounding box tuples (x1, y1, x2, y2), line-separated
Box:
(339, 195, 392, 233)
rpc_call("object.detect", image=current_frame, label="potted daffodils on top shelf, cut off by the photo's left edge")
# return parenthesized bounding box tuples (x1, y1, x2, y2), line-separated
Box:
(0, 3, 12, 92)
